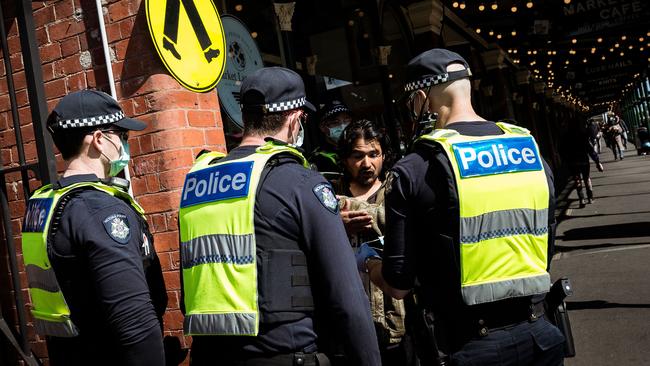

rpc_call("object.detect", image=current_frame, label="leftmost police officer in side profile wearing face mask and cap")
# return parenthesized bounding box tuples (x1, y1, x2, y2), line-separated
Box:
(22, 90, 167, 366)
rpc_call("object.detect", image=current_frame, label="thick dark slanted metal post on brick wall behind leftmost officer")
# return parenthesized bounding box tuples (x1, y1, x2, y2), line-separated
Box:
(16, 0, 56, 184)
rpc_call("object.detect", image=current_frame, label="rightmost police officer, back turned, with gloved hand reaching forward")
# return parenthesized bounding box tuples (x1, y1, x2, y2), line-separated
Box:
(357, 49, 564, 365)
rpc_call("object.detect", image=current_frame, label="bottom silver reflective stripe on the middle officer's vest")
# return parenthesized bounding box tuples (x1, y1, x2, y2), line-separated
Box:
(183, 313, 257, 335)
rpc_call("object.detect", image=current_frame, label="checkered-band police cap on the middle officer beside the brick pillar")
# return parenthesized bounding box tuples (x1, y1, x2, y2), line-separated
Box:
(240, 67, 316, 113)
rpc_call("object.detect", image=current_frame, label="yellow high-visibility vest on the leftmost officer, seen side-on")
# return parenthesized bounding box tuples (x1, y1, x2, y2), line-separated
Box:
(22, 182, 144, 337)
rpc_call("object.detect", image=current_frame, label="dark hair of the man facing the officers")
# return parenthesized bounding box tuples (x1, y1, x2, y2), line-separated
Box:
(338, 119, 395, 176)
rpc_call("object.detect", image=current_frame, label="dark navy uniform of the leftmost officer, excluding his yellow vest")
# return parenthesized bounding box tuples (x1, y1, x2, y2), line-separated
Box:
(47, 174, 167, 366)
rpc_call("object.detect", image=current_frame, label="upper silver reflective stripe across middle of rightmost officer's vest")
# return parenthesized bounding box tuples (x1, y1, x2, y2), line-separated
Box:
(460, 208, 548, 244)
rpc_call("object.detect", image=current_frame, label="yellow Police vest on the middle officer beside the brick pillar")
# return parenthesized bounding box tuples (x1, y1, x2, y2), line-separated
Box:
(178, 142, 308, 336)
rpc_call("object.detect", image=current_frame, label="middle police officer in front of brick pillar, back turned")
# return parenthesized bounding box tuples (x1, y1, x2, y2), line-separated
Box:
(179, 67, 380, 365)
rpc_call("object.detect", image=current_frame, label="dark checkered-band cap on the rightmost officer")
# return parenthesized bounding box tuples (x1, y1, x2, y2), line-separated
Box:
(404, 48, 472, 92)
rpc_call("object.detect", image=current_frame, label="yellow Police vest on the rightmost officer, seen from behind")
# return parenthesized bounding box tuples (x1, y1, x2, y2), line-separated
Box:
(421, 122, 550, 305)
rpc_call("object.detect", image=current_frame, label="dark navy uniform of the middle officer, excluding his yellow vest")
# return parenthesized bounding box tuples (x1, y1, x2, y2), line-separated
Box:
(191, 142, 381, 366)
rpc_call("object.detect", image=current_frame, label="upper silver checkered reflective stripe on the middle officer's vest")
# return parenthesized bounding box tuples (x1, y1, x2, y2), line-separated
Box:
(181, 234, 255, 269)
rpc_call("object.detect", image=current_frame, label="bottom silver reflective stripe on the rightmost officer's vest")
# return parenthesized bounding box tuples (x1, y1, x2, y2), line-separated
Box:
(462, 273, 551, 305)
